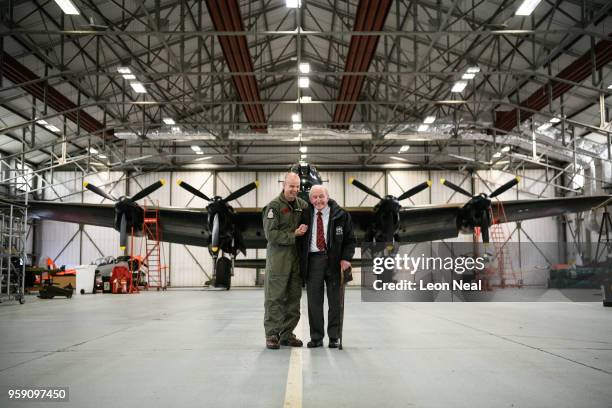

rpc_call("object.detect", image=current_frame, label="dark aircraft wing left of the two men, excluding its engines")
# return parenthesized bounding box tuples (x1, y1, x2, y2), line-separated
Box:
(28, 201, 266, 248)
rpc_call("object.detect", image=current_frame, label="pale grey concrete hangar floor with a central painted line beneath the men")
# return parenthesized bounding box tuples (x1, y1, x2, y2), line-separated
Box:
(0, 289, 612, 408)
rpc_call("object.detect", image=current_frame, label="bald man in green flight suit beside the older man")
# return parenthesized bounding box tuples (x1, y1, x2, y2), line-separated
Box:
(263, 173, 308, 349)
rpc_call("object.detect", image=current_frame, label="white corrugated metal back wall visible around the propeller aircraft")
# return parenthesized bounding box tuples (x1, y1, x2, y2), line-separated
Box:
(37, 170, 557, 287)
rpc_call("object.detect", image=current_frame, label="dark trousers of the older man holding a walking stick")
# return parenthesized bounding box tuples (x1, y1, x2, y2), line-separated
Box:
(306, 254, 340, 340)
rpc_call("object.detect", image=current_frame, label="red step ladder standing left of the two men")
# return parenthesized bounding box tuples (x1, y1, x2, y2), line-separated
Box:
(142, 206, 166, 290)
